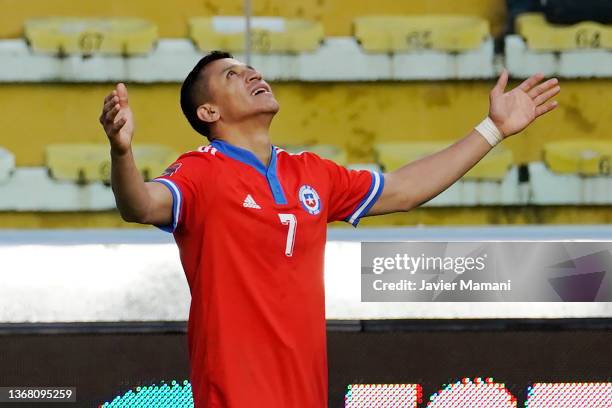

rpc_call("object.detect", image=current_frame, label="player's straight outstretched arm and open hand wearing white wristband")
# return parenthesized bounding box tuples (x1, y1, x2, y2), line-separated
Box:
(368, 70, 560, 215)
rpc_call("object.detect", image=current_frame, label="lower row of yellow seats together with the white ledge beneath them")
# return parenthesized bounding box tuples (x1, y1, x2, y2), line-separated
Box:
(0, 140, 612, 211)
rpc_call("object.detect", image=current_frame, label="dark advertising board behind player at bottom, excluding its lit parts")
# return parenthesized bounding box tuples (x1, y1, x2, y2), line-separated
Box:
(0, 319, 612, 408)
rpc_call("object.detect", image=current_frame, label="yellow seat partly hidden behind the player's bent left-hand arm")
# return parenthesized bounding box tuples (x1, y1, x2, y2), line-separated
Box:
(45, 143, 178, 184)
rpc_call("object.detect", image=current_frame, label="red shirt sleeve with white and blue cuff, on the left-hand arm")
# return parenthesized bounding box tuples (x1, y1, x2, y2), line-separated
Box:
(152, 155, 199, 233)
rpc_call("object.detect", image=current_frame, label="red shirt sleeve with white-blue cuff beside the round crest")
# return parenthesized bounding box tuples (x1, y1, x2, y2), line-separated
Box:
(322, 159, 385, 227)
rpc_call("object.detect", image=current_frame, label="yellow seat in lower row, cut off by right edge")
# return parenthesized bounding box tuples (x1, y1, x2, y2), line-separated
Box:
(544, 139, 612, 176)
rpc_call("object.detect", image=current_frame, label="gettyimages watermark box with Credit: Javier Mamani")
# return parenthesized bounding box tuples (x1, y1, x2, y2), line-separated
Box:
(361, 242, 612, 302)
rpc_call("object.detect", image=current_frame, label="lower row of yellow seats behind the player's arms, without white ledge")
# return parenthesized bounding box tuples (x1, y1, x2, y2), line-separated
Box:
(0, 140, 612, 184)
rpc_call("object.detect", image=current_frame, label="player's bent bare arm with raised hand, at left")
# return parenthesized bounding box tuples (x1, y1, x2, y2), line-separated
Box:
(100, 84, 172, 225)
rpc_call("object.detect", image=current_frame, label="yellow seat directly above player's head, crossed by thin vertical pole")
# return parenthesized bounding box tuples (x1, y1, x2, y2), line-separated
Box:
(189, 16, 324, 54)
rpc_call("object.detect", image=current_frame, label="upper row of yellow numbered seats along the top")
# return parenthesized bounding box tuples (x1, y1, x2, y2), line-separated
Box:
(24, 13, 612, 56)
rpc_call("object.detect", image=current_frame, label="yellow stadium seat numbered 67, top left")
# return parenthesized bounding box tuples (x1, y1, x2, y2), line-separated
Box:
(24, 17, 157, 56)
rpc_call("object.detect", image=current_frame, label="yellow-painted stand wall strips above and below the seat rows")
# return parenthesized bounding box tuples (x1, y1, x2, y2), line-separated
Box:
(0, 0, 612, 228)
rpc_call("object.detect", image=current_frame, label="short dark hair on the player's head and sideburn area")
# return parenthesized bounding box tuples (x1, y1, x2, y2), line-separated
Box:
(181, 51, 234, 138)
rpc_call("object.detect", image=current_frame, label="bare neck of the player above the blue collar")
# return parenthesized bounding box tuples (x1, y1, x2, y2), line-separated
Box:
(214, 118, 271, 167)
